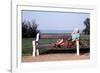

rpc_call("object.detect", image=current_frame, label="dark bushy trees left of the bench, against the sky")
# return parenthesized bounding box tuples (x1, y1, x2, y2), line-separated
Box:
(22, 20, 39, 38)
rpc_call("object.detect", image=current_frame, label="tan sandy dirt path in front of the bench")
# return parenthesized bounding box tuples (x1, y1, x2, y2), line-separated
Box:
(22, 53, 90, 62)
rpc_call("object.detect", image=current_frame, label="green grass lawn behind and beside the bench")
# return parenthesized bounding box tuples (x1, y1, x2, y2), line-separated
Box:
(22, 33, 90, 55)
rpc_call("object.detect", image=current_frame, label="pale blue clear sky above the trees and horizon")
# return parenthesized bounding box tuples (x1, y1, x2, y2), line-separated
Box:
(21, 10, 90, 31)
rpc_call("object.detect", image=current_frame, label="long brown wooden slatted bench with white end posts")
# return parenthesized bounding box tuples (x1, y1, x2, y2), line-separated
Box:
(32, 33, 88, 56)
